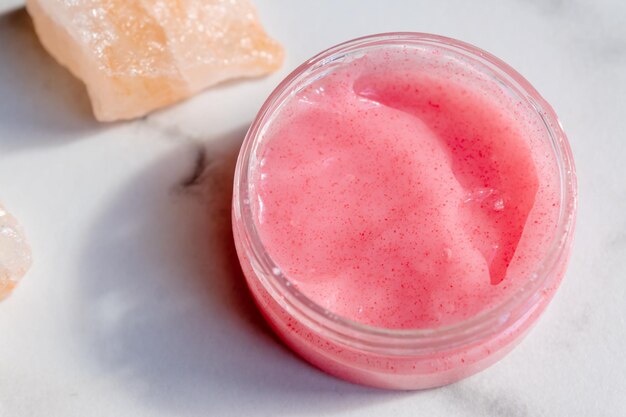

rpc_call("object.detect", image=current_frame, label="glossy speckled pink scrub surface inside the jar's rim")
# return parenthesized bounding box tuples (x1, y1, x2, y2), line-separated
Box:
(251, 48, 560, 329)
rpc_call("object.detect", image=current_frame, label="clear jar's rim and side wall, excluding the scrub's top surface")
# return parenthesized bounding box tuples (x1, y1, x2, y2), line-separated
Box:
(232, 33, 576, 389)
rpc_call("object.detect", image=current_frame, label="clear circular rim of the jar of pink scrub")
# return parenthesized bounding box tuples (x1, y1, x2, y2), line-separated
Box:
(233, 32, 577, 353)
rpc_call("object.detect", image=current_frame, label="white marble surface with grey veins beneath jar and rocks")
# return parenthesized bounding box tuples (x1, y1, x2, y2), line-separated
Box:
(0, 0, 626, 417)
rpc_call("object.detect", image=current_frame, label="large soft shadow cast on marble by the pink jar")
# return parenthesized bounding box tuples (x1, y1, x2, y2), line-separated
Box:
(77, 128, 400, 416)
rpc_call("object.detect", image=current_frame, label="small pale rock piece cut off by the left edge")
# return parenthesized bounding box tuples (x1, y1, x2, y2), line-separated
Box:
(0, 205, 31, 300)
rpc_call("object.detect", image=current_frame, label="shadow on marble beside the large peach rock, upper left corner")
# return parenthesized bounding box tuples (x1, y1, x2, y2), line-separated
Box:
(0, 9, 105, 153)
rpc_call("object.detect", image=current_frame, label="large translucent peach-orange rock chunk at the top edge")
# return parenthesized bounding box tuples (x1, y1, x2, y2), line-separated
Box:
(26, 0, 283, 121)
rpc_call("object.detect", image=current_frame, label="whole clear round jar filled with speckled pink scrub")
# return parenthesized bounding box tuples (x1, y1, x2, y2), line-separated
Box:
(233, 33, 576, 389)
